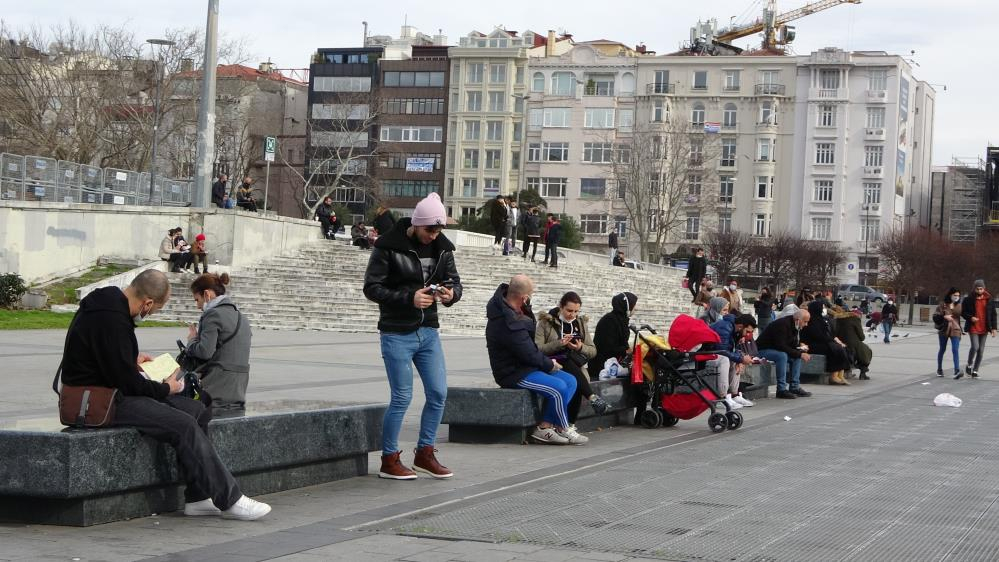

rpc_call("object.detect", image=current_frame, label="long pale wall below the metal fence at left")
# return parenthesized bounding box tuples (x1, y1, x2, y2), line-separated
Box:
(0, 201, 320, 283)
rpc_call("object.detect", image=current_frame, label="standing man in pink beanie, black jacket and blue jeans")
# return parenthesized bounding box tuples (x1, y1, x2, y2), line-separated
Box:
(364, 193, 461, 480)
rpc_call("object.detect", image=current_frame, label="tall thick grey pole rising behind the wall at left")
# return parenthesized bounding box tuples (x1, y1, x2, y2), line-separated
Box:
(191, 0, 219, 208)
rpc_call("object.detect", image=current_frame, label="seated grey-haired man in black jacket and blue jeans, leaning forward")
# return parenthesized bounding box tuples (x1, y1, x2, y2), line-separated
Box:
(756, 309, 812, 398)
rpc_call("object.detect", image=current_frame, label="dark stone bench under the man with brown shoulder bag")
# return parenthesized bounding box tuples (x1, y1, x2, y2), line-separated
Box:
(0, 401, 386, 527)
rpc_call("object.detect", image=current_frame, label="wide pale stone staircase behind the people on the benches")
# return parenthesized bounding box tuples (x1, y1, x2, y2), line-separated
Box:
(157, 241, 690, 335)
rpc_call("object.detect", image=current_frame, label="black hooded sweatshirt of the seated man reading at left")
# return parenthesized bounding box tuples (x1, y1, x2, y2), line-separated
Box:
(62, 287, 170, 399)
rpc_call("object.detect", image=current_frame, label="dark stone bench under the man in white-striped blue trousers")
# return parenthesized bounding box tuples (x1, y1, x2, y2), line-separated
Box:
(441, 379, 635, 445)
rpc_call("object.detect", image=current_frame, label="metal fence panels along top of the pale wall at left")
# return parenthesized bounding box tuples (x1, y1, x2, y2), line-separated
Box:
(0, 153, 192, 207)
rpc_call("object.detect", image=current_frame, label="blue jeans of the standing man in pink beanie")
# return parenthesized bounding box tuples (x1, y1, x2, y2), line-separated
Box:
(381, 328, 447, 455)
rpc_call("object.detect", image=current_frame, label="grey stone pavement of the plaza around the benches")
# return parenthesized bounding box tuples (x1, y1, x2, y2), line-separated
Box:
(0, 322, 999, 562)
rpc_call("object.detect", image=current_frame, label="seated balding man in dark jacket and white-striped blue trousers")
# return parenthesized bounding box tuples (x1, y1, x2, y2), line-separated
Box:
(486, 274, 589, 445)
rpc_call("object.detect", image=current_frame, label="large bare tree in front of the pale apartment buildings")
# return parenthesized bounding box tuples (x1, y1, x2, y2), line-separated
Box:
(608, 115, 719, 261)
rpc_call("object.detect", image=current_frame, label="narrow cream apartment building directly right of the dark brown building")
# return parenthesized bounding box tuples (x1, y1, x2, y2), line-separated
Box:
(445, 28, 572, 219)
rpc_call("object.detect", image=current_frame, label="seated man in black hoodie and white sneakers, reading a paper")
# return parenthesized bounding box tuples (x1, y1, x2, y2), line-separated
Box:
(62, 270, 271, 521)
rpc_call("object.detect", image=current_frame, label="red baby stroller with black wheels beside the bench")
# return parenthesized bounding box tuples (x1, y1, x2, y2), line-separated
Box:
(630, 314, 742, 433)
